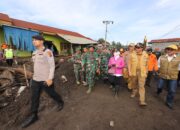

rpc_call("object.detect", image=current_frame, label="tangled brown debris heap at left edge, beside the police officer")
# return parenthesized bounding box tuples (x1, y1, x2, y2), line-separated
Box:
(0, 66, 32, 108)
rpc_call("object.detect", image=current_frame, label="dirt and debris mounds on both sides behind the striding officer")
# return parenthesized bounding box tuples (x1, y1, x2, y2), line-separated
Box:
(0, 59, 75, 128)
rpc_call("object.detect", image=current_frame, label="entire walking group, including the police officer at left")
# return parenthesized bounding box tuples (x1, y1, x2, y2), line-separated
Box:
(19, 35, 180, 128)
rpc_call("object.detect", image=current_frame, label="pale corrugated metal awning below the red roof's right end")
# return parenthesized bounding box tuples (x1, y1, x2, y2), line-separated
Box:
(58, 34, 97, 45)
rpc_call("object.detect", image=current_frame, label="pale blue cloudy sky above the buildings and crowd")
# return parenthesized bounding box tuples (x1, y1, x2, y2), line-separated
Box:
(0, 0, 180, 44)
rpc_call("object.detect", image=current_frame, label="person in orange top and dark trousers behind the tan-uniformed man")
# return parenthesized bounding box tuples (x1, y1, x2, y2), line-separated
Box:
(146, 48, 158, 87)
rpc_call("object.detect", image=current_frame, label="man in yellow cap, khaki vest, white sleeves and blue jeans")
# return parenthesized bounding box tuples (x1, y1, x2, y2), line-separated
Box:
(157, 45, 180, 109)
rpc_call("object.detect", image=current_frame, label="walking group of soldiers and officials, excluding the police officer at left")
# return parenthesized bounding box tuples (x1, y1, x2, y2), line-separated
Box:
(71, 43, 180, 109)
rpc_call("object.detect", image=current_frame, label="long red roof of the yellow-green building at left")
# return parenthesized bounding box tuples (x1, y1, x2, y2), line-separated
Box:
(0, 13, 92, 40)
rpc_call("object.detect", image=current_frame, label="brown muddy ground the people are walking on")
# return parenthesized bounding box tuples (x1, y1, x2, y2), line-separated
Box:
(0, 62, 180, 130)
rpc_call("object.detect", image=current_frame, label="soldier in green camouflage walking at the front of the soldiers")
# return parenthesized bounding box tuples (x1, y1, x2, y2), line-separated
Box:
(82, 46, 100, 94)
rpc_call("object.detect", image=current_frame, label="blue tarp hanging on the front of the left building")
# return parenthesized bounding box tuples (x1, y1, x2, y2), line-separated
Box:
(3, 25, 39, 51)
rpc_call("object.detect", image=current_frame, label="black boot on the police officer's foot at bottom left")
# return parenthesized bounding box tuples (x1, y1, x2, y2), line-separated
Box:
(21, 114, 38, 128)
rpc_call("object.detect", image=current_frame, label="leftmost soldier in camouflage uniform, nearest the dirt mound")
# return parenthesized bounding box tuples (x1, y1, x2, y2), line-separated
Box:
(71, 48, 82, 85)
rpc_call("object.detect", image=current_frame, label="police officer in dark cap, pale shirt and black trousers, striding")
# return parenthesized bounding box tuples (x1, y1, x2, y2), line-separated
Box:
(22, 35, 64, 128)
